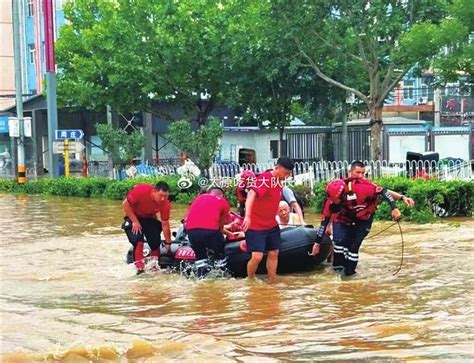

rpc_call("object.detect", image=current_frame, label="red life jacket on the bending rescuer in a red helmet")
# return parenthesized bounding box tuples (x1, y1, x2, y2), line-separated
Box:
(336, 178, 382, 222)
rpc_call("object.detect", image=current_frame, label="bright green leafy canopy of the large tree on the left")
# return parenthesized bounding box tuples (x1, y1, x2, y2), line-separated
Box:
(57, 0, 237, 125)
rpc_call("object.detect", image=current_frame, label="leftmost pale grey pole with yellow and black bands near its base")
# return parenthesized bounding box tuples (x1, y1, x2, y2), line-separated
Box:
(12, 0, 26, 184)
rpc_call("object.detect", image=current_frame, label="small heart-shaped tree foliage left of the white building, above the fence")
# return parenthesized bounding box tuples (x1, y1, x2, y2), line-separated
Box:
(167, 117, 223, 170)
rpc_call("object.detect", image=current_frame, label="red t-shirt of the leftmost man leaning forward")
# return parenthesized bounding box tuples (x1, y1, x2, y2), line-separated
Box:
(127, 184, 171, 221)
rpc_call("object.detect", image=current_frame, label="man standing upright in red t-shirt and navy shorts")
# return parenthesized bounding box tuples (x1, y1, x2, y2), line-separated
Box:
(242, 156, 294, 283)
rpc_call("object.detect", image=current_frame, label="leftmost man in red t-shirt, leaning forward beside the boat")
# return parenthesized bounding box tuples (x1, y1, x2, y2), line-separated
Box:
(122, 182, 171, 275)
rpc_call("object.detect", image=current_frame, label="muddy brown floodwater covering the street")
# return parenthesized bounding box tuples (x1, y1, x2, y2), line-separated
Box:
(0, 195, 474, 362)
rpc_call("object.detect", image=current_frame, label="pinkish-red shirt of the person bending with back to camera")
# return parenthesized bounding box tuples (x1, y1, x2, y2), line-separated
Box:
(185, 194, 230, 230)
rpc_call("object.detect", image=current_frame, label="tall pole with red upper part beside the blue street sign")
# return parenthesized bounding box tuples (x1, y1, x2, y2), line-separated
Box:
(43, 0, 59, 178)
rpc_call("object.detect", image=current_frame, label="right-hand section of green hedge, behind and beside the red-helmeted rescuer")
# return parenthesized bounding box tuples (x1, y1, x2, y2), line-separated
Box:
(311, 177, 474, 223)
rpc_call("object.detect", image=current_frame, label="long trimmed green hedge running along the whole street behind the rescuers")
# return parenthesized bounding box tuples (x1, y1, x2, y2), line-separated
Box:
(0, 176, 474, 223)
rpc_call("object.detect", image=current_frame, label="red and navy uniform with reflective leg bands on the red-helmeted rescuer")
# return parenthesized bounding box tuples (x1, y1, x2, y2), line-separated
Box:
(317, 178, 396, 276)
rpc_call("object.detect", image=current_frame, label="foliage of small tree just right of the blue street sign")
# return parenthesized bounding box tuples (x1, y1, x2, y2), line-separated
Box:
(96, 124, 145, 167)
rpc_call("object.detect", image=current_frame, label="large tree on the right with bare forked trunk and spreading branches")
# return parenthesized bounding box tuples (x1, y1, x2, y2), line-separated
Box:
(292, 0, 467, 160)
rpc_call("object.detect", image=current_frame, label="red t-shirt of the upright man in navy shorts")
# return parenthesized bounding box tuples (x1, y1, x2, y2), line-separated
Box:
(249, 170, 283, 231)
